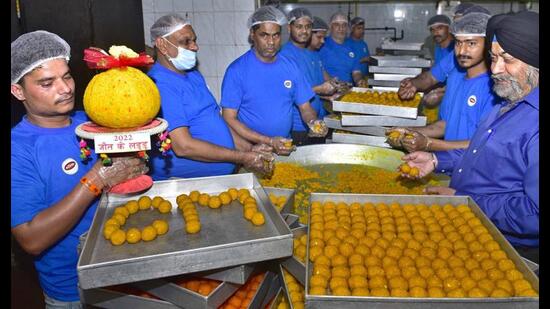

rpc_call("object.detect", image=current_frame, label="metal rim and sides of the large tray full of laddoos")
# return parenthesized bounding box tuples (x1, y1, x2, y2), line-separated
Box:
(306, 193, 539, 309)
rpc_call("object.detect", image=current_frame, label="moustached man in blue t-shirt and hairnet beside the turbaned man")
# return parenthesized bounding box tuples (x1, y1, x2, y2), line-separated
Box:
(388, 13, 496, 152)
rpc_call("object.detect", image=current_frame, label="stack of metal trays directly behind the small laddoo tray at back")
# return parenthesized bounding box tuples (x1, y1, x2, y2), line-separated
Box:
(368, 55, 431, 91)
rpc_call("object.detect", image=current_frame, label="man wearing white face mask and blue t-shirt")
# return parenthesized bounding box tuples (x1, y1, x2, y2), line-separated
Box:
(148, 14, 273, 180)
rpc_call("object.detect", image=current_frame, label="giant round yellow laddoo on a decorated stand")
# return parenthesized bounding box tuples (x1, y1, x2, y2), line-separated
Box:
(84, 67, 160, 129)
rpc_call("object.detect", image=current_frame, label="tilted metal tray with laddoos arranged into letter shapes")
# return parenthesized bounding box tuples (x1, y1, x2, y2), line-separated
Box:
(77, 173, 292, 289)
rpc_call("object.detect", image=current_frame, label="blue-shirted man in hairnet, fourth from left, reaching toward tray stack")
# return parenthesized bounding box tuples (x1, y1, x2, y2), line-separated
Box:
(280, 8, 336, 146)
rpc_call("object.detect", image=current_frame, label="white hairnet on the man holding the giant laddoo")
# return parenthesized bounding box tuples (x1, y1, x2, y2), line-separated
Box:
(11, 30, 71, 83)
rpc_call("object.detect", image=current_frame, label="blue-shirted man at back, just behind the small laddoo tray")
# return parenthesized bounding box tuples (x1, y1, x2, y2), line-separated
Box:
(319, 13, 367, 87)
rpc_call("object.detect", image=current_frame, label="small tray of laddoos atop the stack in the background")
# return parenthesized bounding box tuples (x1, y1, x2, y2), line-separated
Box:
(332, 87, 422, 119)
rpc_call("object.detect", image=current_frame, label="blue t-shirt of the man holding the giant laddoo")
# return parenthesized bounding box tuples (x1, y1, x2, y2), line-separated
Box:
(11, 112, 97, 301)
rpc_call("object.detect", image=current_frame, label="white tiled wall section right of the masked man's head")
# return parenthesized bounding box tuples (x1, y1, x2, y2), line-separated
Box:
(142, 0, 256, 102)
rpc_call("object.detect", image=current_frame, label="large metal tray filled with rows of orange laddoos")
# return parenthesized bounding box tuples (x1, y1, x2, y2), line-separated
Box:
(305, 193, 539, 309)
